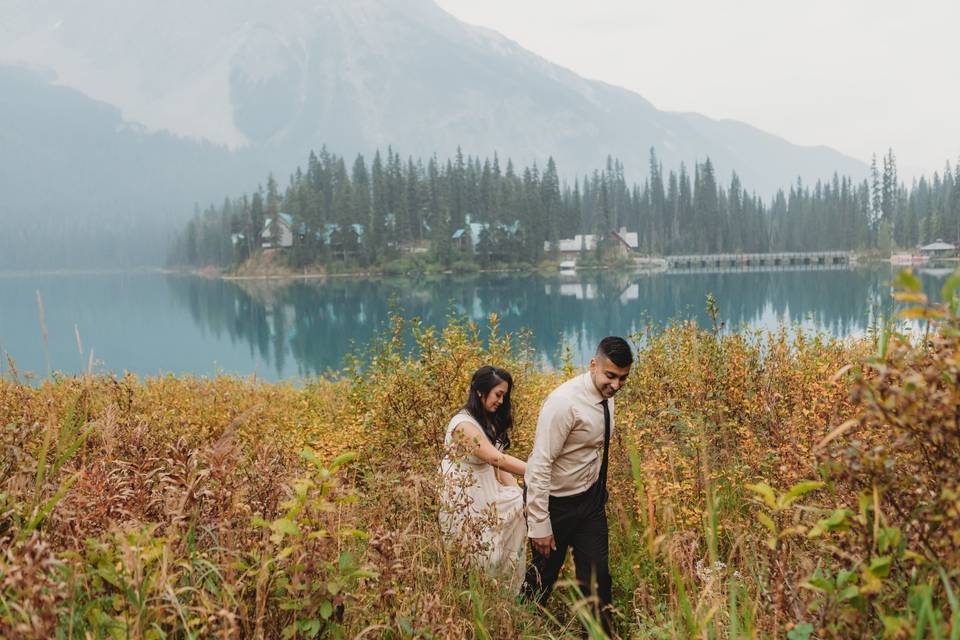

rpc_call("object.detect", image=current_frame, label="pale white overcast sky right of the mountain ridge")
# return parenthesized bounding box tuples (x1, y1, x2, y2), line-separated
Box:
(437, 0, 960, 177)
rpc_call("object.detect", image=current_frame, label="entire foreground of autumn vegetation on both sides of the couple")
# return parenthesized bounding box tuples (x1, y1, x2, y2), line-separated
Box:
(0, 272, 960, 640)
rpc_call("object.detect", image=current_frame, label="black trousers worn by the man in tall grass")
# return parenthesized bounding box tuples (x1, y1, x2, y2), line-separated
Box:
(523, 481, 613, 636)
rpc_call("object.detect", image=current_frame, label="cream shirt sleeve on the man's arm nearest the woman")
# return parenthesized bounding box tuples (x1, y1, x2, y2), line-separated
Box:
(523, 396, 574, 538)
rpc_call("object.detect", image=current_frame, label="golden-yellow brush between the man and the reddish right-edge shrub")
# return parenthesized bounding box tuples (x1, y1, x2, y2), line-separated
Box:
(611, 299, 867, 638)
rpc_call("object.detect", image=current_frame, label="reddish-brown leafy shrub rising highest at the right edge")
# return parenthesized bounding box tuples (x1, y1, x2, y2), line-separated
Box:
(788, 272, 960, 640)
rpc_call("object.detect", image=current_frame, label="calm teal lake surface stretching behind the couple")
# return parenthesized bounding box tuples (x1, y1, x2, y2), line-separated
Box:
(0, 266, 942, 380)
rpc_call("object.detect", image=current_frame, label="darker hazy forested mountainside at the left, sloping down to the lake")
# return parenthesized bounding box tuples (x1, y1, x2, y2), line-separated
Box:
(0, 66, 266, 269)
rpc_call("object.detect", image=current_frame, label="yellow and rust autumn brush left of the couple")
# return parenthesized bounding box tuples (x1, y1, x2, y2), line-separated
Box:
(0, 312, 563, 638)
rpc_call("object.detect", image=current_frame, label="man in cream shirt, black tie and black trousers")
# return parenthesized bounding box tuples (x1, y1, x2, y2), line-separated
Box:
(523, 336, 633, 635)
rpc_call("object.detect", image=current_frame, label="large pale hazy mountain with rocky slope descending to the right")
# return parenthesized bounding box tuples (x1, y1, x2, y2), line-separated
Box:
(0, 0, 866, 195)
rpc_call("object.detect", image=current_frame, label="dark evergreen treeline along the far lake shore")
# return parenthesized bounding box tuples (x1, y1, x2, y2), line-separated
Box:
(170, 148, 960, 268)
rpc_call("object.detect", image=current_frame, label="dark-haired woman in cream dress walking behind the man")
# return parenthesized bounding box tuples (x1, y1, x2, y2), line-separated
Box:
(440, 366, 527, 593)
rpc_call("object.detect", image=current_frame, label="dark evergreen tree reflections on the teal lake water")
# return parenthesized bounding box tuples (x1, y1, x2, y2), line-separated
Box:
(168, 268, 908, 378)
